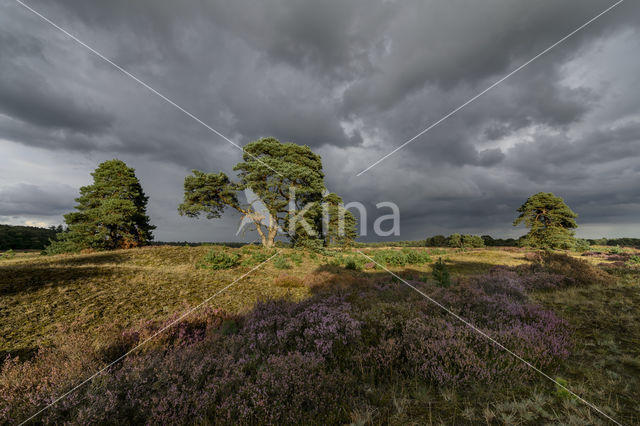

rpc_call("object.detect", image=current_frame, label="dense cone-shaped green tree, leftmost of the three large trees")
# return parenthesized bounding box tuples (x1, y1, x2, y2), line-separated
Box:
(47, 160, 155, 254)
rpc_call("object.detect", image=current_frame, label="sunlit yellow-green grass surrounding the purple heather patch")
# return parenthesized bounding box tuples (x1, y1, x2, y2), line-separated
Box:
(0, 246, 640, 424)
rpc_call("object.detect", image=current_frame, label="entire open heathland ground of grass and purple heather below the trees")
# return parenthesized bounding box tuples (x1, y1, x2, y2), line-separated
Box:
(0, 246, 640, 424)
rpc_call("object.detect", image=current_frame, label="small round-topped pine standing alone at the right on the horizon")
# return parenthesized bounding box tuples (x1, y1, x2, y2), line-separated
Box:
(513, 192, 578, 249)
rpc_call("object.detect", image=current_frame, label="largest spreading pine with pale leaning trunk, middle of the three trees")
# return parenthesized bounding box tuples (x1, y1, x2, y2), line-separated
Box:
(178, 138, 355, 247)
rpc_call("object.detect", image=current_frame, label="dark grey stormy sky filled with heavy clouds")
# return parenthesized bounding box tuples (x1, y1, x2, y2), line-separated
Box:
(0, 0, 640, 241)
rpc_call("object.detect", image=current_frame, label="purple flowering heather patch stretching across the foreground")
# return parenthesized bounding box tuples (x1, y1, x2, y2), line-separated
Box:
(0, 256, 581, 424)
